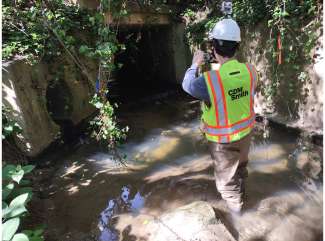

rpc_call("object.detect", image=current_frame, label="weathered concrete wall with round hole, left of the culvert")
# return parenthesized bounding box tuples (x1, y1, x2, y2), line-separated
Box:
(2, 57, 95, 156)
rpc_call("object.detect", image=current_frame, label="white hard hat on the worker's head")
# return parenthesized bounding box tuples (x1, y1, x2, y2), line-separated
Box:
(209, 18, 241, 42)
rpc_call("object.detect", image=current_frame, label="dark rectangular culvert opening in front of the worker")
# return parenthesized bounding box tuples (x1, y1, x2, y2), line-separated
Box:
(108, 26, 177, 102)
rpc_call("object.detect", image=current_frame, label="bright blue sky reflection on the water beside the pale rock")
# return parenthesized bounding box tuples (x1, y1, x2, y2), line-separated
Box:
(98, 186, 145, 241)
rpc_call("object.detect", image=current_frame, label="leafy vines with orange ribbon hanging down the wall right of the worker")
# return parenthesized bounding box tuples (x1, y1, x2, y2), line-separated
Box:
(265, 0, 320, 112)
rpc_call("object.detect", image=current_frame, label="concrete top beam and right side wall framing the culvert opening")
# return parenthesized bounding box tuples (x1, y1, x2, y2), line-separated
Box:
(67, 0, 191, 83)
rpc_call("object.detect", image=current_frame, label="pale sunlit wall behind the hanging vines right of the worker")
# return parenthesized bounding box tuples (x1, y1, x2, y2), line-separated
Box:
(239, 23, 324, 134)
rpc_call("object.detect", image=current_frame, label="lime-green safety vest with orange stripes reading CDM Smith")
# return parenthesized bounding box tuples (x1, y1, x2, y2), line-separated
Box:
(202, 60, 257, 143)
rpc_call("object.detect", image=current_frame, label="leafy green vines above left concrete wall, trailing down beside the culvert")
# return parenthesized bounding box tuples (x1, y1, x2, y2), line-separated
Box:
(2, 0, 127, 151)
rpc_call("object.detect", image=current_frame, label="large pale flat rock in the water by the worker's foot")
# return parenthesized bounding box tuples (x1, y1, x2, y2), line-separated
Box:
(146, 201, 235, 241)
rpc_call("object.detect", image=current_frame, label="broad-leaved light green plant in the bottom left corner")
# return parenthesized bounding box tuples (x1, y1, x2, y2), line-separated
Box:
(2, 165, 44, 241)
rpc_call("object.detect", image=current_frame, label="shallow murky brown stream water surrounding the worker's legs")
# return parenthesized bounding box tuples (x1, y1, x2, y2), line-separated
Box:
(36, 95, 323, 241)
